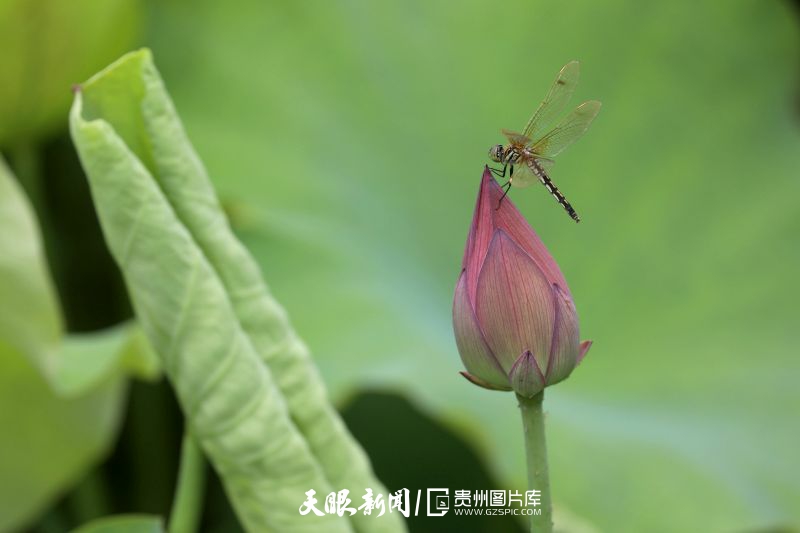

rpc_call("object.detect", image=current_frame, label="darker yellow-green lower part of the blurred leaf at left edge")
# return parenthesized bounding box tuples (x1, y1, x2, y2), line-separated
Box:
(0, 339, 126, 531)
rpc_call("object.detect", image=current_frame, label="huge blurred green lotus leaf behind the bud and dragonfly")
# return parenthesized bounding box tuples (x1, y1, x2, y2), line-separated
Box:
(141, 0, 800, 533)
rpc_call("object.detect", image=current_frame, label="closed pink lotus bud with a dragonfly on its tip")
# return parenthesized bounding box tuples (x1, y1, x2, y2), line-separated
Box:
(453, 169, 592, 398)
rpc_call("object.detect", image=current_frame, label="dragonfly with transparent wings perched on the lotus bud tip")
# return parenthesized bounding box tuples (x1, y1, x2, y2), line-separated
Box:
(489, 61, 600, 222)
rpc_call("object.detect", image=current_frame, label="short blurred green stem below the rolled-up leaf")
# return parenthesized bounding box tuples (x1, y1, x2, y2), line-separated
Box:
(168, 431, 206, 533)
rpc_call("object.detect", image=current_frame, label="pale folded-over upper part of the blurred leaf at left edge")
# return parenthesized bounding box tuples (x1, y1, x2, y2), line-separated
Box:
(0, 154, 159, 396)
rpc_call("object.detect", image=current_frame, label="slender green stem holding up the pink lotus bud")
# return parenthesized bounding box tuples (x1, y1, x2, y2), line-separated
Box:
(517, 391, 553, 533)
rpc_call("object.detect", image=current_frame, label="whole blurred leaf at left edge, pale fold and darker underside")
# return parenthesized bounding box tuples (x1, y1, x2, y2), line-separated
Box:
(0, 158, 158, 531)
